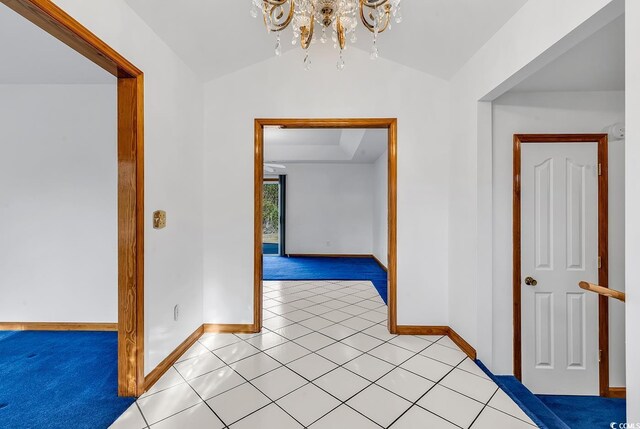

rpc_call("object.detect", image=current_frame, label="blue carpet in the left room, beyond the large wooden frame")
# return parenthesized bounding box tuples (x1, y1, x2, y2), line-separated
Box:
(0, 331, 134, 429)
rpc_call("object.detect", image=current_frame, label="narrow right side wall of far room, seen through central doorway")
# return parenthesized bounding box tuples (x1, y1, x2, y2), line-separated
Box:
(373, 150, 389, 267)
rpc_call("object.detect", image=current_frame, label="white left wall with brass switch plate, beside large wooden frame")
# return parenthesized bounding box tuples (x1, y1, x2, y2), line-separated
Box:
(54, 0, 203, 373)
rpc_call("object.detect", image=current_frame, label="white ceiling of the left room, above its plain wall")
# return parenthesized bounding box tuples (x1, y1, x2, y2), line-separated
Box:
(0, 4, 116, 85)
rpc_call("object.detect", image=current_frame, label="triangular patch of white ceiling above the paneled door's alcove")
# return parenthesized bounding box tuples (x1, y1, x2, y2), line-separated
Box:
(511, 15, 625, 92)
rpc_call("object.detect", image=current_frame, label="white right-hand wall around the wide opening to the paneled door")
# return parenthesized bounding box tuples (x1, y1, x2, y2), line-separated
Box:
(449, 0, 640, 414)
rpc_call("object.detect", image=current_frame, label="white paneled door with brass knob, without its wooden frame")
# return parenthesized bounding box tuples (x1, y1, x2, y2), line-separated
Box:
(521, 143, 599, 395)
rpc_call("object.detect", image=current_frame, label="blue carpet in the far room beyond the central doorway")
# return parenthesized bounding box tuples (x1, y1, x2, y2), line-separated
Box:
(262, 256, 387, 304)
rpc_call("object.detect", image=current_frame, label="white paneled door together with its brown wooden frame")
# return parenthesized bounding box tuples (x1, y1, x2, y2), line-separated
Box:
(513, 134, 610, 396)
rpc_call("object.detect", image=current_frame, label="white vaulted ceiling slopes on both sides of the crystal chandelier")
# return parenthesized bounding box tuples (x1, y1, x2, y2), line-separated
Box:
(126, 0, 527, 81)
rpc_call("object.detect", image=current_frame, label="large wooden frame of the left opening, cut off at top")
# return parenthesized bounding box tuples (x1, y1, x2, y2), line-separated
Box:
(0, 0, 144, 396)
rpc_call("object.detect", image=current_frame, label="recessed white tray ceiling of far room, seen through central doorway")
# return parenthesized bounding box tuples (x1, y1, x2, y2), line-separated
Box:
(264, 127, 387, 164)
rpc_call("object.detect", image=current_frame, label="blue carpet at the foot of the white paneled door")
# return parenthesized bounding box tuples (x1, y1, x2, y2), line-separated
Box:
(537, 395, 627, 429)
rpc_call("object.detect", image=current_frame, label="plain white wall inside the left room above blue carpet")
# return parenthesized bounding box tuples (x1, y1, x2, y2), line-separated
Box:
(0, 83, 118, 322)
